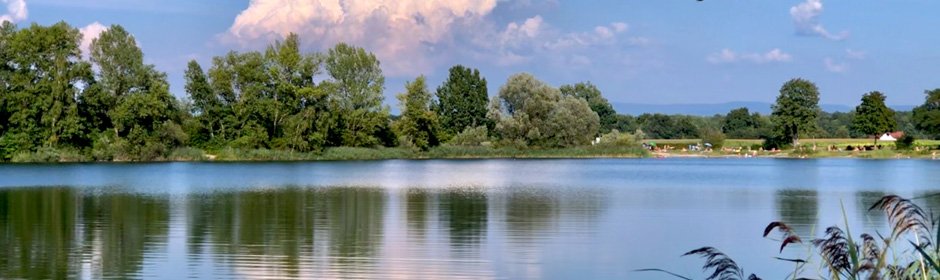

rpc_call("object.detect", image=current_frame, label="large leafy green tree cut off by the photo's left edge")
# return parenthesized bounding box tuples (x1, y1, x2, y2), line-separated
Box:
(0, 22, 91, 157)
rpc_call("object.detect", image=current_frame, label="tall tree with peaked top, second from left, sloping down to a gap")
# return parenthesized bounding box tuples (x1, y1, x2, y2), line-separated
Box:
(90, 25, 187, 160)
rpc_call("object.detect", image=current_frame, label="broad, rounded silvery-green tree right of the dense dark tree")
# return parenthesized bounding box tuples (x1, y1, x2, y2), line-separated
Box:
(488, 74, 600, 147)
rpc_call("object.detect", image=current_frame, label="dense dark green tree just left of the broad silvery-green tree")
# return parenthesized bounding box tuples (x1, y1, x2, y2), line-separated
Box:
(435, 65, 490, 137)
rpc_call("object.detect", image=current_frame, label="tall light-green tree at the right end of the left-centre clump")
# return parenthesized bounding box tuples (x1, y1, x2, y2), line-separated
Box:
(325, 43, 388, 147)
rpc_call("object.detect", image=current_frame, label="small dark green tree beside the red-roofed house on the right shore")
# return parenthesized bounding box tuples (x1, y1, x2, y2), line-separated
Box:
(852, 91, 898, 143)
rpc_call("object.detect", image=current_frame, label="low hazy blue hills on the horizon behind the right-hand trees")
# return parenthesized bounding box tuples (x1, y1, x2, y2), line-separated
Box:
(611, 101, 914, 116)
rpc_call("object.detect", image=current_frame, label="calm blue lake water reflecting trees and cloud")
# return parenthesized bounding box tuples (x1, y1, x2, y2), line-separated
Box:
(0, 159, 940, 279)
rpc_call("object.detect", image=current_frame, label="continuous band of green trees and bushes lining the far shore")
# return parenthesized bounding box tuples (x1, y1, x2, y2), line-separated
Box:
(0, 22, 940, 162)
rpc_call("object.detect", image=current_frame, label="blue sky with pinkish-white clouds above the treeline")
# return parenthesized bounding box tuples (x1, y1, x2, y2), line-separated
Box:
(0, 0, 940, 107)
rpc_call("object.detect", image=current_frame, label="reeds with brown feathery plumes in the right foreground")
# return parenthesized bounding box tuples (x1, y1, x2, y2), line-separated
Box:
(638, 195, 940, 280)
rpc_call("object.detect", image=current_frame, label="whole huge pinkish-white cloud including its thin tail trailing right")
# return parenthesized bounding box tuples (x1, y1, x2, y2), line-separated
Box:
(220, 0, 649, 76)
